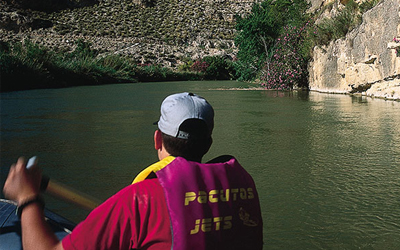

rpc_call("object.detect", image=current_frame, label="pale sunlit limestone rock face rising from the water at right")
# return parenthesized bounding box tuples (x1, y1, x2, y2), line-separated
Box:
(309, 0, 400, 99)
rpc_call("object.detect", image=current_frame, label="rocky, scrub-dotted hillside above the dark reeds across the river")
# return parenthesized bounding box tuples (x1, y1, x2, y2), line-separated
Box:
(0, 0, 259, 67)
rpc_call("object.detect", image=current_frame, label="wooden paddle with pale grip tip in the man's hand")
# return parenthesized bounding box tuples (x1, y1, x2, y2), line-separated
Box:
(26, 156, 101, 210)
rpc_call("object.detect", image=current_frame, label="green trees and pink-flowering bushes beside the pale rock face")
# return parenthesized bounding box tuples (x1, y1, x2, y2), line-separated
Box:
(235, 0, 380, 90)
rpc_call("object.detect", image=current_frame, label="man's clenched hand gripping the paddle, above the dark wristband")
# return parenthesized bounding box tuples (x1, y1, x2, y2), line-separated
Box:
(3, 157, 42, 205)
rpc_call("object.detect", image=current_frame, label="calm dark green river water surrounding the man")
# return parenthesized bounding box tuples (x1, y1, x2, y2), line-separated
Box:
(0, 82, 400, 249)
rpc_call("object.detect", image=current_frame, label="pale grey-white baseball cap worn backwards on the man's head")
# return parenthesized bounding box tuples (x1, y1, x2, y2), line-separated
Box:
(157, 92, 214, 139)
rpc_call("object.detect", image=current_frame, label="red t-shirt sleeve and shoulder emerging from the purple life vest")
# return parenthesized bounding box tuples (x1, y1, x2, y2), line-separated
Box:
(62, 179, 172, 250)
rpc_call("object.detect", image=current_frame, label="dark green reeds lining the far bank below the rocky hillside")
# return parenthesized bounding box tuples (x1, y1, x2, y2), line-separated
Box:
(0, 40, 236, 91)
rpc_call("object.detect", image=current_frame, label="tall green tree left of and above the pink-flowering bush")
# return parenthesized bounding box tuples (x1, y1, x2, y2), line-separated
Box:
(235, 0, 308, 81)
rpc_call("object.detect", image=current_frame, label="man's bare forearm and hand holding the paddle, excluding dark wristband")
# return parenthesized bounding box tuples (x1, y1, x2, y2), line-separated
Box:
(3, 158, 63, 250)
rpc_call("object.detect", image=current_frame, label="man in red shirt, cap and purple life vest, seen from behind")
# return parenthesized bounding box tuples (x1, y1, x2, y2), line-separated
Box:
(3, 93, 262, 250)
